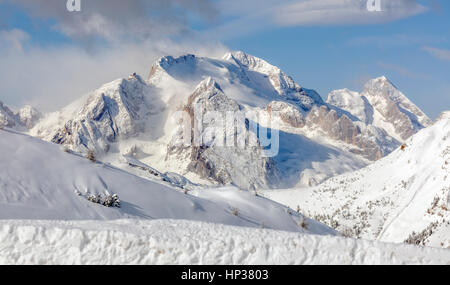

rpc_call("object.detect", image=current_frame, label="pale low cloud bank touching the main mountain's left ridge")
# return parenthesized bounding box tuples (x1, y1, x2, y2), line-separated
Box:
(0, 30, 227, 111)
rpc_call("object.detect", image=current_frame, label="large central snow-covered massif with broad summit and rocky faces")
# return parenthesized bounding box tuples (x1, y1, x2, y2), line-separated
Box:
(30, 52, 428, 189)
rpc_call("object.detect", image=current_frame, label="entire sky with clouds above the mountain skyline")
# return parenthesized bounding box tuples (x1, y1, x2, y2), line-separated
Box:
(0, 0, 450, 118)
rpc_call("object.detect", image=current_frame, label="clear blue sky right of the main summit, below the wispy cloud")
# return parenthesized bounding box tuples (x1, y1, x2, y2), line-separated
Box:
(219, 1, 450, 118)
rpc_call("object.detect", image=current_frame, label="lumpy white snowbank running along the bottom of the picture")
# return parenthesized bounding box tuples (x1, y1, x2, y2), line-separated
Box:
(0, 220, 450, 265)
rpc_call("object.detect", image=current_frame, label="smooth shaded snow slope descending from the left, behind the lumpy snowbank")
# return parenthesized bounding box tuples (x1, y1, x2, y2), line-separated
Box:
(0, 127, 334, 234)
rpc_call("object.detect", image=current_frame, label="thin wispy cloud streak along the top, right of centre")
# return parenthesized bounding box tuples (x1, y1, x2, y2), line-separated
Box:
(206, 0, 428, 39)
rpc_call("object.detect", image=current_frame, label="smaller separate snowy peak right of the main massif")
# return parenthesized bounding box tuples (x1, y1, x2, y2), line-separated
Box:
(327, 76, 432, 142)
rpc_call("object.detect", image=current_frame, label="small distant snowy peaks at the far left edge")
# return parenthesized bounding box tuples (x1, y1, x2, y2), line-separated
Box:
(0, 101, 42, 130)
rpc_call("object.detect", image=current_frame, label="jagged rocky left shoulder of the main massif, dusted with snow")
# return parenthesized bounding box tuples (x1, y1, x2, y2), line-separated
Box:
(32, 75, 158, 153)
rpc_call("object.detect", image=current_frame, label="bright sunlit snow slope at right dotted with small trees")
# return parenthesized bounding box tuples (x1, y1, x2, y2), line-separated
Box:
(264, 112, 450, 247)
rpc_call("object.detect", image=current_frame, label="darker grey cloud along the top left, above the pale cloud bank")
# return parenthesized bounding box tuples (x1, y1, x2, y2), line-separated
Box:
(4, 0, 218, 44)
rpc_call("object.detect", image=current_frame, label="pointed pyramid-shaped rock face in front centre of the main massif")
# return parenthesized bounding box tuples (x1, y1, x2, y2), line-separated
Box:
(168, 78, 279, 189)
